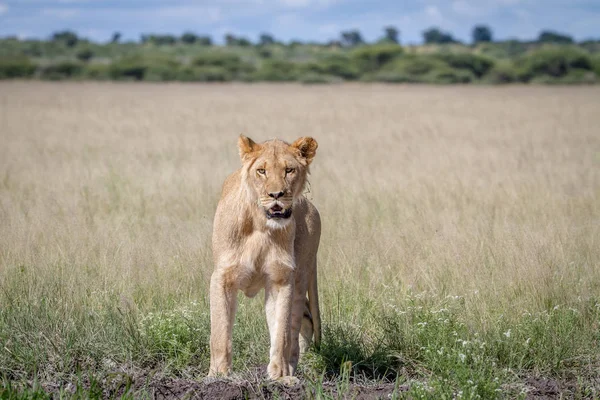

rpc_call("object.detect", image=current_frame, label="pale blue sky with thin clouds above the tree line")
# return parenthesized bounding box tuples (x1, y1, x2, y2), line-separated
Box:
(0, 0, 600, 43)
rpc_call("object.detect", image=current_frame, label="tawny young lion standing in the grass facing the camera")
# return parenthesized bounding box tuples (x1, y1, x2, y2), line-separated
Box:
(209, 135, 321, 379)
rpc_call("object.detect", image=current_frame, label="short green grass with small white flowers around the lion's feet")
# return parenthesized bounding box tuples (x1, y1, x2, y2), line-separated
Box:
(1, 282, 600, 399)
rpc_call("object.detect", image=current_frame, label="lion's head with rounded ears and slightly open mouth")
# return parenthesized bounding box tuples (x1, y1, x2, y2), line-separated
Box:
(238, 135, 318, 226)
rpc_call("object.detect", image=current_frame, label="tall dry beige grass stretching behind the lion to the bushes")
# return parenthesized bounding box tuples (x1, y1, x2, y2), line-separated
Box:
(0, 83, 600, 394)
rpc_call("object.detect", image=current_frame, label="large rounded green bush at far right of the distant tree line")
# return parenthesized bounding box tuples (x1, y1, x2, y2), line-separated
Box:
(517, 47, 594, 81)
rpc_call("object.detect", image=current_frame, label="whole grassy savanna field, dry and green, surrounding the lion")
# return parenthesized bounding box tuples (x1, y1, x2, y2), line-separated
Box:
(0, 82, 600, 399)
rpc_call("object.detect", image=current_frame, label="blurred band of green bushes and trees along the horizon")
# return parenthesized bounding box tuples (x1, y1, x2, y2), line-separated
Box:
(0, 25, 600, 84)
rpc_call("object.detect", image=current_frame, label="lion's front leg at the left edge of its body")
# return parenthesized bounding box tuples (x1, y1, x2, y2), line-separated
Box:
(208, 269, 237, 376)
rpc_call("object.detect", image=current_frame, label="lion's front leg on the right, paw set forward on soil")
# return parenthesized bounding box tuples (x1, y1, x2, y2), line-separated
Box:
(265, 266, 294, 379)
